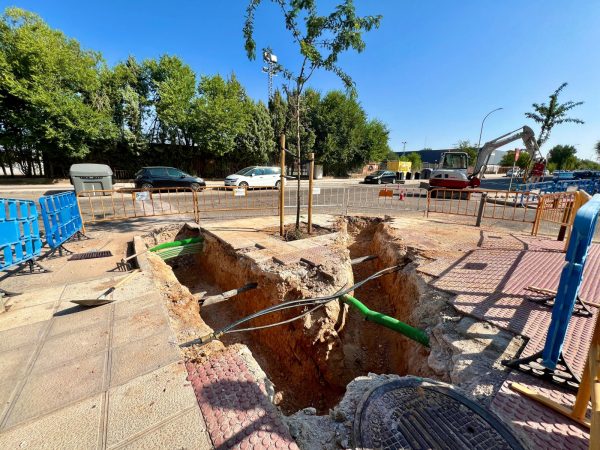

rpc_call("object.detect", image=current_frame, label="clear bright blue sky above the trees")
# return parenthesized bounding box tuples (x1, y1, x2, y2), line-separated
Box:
(5, 0, 600, 159)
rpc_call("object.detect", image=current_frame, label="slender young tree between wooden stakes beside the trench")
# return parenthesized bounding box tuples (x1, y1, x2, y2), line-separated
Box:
(243, 0, 381, 230)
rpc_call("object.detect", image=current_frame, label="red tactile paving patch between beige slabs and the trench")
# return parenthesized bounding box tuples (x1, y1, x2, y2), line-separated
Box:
(186, 349, 298, 450)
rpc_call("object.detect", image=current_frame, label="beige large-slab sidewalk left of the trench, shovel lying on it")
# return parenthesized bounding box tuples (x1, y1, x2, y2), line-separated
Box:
(0, 273, 212, 449)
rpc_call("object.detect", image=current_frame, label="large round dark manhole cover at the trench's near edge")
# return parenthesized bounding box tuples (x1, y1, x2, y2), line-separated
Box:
(354, 378, 522, 450)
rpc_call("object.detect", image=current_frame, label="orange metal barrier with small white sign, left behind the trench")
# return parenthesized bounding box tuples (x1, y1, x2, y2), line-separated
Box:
(77, 187, 199, 224)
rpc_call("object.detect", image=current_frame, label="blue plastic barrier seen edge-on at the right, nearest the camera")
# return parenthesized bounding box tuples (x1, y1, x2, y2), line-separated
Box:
(542, 194, 600, 369)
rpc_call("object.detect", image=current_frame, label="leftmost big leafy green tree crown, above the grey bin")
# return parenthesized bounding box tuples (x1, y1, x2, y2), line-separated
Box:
(0, 8, 116, 176)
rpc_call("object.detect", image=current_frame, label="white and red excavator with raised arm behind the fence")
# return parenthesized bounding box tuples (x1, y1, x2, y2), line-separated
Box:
(429, 126, 541, 189)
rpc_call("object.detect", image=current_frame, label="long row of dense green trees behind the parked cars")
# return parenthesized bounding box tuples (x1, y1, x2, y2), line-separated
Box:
(0, 5, 388, 176)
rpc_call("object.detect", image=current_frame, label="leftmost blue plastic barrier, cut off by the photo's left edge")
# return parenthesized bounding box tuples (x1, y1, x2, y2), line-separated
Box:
(0, 198, 42, 271)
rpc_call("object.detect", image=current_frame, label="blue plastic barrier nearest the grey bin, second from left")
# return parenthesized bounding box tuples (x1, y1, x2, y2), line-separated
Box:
(40, 192, 83, 250)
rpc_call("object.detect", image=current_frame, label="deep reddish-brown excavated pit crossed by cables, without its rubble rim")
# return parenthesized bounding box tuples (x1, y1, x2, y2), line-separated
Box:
(173, 218, 434, 414)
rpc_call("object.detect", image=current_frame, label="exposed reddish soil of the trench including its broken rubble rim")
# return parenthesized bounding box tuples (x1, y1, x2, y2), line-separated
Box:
(141, 217, 522, 449)
